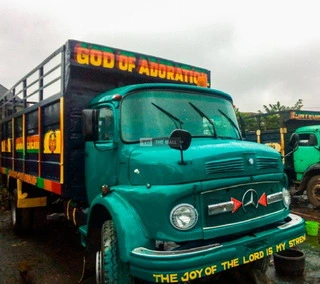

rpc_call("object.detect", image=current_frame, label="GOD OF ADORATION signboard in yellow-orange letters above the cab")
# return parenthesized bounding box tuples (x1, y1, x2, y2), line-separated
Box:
(70, 41, 210, 87)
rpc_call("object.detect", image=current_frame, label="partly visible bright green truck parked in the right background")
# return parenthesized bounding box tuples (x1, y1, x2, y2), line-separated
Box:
(247, 110, 320, 208)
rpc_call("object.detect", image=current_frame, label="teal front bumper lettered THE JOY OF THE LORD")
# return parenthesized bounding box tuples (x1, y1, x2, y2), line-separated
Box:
(130, 214, 306, 283)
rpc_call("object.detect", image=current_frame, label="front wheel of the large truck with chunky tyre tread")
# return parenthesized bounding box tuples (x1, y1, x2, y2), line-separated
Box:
(96, 220, 133, 284)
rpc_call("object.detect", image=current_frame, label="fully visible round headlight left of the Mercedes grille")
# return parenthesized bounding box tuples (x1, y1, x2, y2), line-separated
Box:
(170, 203, 198, 230)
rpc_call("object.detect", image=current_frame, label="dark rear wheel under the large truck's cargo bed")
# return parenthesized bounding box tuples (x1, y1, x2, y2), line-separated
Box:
(10, 189, 32, 234)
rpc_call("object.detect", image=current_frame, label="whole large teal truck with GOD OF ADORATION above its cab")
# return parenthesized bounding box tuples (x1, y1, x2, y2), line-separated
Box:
(0, 40, 306, 283)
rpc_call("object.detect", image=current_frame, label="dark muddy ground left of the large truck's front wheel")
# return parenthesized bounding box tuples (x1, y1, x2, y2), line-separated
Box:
(0, 207, 87, 284)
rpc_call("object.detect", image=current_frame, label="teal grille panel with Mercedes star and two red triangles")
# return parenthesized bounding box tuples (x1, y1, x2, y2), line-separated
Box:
(201, 181, 284, 236)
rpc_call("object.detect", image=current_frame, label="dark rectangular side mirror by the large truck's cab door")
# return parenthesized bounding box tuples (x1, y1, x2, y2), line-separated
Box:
(82, 109, 99, 141)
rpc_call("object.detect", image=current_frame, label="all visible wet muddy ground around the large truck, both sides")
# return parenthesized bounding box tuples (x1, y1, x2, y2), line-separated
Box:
(0, 192, 320, 284)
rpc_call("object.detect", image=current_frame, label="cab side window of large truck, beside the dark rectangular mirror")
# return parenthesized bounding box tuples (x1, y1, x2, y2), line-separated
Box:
(99, 107, 114, 140)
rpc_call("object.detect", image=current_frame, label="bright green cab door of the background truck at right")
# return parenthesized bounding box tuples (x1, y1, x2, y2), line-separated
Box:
(293, 133, 320, 181)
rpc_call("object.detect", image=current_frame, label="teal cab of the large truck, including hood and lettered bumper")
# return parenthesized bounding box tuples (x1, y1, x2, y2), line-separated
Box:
(80, 84, 304, 283)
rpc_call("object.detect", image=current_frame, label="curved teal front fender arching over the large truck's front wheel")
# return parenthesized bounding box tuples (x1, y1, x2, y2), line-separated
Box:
(88, 191, 151, 262)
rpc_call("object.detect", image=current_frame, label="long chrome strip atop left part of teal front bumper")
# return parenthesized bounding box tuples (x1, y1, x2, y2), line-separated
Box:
(131, 243, 222, 257)
